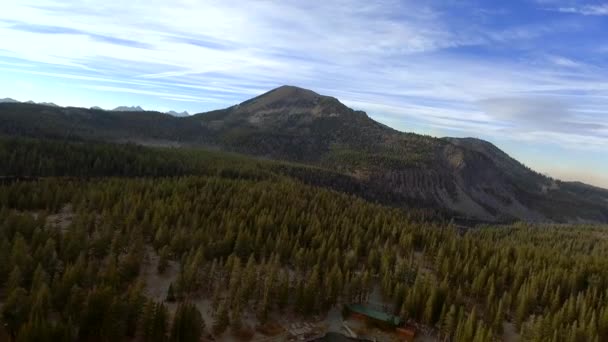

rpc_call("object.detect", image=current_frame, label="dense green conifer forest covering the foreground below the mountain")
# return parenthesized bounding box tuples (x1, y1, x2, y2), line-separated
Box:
(0, 140, 608, 342)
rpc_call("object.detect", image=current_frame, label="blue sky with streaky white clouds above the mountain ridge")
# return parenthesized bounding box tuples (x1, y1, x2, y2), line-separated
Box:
(0, 0, 608, 188)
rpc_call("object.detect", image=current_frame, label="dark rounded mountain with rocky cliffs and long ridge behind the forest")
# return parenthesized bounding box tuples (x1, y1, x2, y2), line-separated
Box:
(0, 86, 608, 222)
